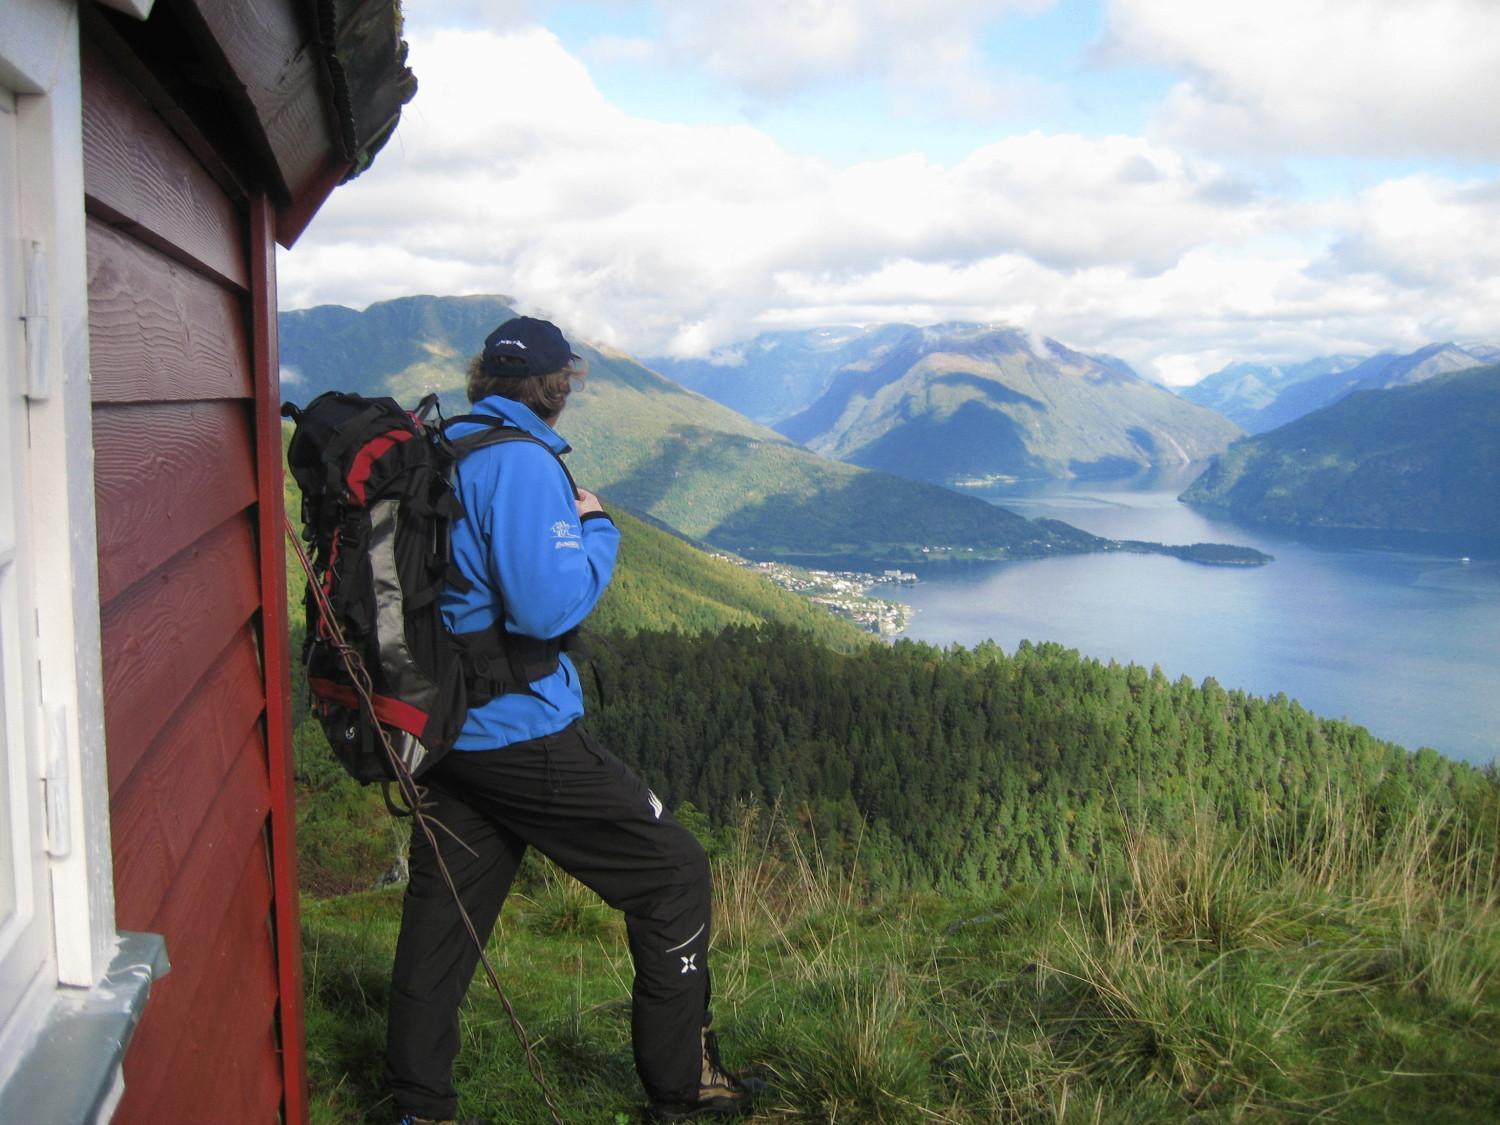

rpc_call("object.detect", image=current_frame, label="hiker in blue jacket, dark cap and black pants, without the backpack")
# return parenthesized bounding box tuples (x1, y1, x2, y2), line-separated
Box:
(386, 317, 761, 1122)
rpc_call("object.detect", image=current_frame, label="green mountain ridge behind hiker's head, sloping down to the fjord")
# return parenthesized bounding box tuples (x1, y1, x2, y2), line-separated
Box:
(279, 297, 1265, 564)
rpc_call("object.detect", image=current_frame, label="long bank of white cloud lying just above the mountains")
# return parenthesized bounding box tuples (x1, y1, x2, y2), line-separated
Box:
(281, 29, 1500, 381)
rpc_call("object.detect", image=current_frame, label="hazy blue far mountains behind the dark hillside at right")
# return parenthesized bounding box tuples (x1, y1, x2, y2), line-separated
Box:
(1179, 344, 1500, 434)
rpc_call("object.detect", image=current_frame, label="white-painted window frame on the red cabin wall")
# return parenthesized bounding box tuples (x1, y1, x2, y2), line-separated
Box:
(0, 0, 165, 1121)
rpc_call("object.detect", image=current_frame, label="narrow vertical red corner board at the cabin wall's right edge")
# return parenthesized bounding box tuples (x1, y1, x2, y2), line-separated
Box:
(249, 195, 308, 1125)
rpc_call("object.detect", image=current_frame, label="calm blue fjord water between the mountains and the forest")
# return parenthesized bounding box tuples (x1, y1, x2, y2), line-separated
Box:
(894, 471, 1500, 764)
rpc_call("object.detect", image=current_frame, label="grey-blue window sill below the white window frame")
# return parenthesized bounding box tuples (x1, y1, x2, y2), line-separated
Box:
(0, 933, 170, 1125)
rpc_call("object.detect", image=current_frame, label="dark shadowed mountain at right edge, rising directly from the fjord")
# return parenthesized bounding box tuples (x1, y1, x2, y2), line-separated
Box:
(1182, 363, 1500, 539)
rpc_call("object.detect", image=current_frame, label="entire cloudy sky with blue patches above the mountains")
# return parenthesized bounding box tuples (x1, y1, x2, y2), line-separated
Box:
(279, 0, 1500, 384)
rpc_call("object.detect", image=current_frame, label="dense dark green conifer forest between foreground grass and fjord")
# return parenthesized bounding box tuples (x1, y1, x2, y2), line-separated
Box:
(579, 627, 1481, 888)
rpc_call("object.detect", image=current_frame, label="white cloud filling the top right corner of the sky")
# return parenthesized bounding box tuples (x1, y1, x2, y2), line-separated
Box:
(1103, 0, 1500, 162)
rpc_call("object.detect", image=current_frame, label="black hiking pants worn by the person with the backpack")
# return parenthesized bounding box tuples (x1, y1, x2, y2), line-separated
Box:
(386, 723, 710, 1119)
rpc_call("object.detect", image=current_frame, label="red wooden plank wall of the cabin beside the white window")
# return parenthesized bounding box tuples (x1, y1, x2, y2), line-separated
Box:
(84, 33, 305, 1122)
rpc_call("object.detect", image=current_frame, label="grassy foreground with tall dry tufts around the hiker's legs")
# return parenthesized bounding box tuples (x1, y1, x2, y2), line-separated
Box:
(303, 780, 1500, 1125)
